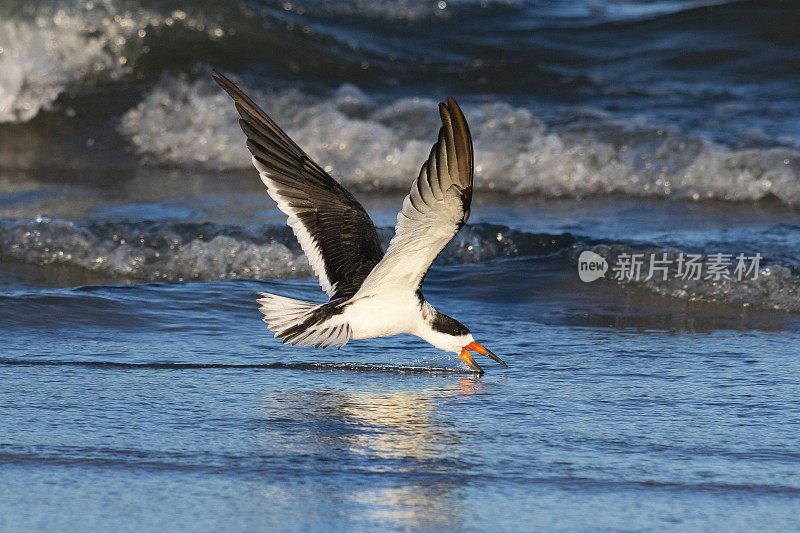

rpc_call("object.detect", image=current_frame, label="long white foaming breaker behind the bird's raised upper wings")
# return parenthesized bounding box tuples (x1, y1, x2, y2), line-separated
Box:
(120, 76, 800, 203)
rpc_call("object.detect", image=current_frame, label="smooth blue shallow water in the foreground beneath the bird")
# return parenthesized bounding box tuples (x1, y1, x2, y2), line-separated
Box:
(0, 254, 800, 531)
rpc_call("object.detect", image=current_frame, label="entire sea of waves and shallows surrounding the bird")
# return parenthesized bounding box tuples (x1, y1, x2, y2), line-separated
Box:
(0, 0, 800, 531)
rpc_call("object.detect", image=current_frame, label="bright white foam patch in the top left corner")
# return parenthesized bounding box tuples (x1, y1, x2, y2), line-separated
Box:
(0, 0, 228, 123)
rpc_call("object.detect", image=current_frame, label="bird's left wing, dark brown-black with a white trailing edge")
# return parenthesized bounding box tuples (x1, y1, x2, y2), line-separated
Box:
(214, 72, 383, 300)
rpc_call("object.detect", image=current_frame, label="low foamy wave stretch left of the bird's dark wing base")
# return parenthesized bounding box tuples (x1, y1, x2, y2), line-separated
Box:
(0, 218, 311, 281)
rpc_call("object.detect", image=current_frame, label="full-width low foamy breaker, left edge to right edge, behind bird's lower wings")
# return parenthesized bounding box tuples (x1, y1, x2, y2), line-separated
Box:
(0, 218, 800, 313)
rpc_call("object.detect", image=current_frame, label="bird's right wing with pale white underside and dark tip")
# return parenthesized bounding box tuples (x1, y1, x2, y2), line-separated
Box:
(358, 98, 475, 296)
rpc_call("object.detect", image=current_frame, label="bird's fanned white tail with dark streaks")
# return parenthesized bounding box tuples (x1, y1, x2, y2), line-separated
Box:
(256, 292, 351, 348)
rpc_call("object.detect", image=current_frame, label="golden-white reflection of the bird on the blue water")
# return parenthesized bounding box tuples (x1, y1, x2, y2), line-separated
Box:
(262, 377, 485, 527)
